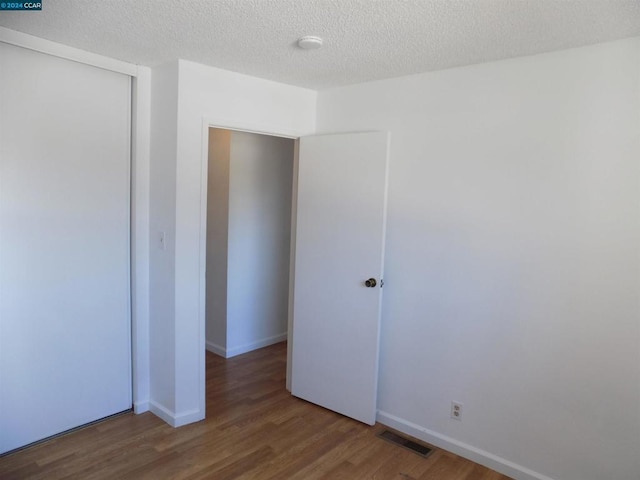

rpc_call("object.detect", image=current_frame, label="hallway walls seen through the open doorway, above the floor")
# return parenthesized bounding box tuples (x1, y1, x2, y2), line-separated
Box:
(205, 127, 295, 366)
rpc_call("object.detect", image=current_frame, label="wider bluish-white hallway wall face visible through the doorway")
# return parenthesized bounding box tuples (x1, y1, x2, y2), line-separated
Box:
(226, 132, 294, 357)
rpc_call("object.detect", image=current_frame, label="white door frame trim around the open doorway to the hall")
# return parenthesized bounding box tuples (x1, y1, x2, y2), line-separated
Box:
(198, 116, 310, 402)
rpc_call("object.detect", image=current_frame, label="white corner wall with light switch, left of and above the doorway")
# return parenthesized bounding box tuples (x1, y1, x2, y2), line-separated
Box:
(150, 60, 316, 426)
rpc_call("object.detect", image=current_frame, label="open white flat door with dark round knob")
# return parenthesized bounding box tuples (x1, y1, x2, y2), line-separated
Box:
(291, 132, 389, 425)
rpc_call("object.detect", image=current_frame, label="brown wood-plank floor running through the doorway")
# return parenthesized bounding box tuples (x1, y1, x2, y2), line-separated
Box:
(0, 343, 508, 480)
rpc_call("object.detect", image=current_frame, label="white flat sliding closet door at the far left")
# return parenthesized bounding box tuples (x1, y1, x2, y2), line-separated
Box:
(0, 43, 131, 452)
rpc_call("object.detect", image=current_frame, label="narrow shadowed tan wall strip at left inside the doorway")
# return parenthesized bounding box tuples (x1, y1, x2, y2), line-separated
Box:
(206, 128, 231, 357)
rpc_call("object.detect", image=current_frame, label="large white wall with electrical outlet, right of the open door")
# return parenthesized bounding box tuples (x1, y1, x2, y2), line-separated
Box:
(318, 39, 640, 480)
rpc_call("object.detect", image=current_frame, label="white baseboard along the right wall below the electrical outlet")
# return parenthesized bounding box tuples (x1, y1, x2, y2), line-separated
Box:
(377, 410, 553, 480)
